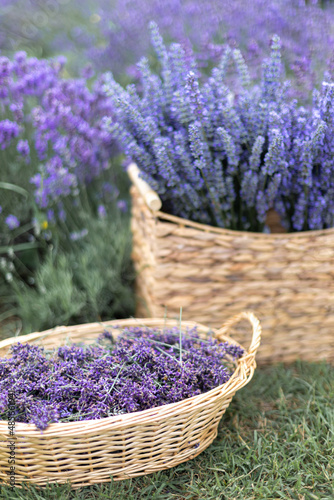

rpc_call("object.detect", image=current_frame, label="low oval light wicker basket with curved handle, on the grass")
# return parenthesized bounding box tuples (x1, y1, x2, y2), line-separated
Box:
(0, 312, 261, 488)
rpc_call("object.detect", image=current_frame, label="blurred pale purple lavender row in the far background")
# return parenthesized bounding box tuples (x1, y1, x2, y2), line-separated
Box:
(0, 0, 334, 97)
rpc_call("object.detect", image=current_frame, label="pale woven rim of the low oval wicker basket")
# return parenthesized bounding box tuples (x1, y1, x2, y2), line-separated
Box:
(0, 313, 261, 438)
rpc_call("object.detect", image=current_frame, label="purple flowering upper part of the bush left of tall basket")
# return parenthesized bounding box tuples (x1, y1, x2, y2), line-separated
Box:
(0, 52, 126, 256)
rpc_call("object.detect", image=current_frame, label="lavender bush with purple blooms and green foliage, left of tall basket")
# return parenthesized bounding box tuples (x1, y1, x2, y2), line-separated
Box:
(0, 52, 132, 331)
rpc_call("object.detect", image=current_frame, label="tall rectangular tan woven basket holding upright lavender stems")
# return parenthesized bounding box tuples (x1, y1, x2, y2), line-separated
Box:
(129, 164, 334, 363)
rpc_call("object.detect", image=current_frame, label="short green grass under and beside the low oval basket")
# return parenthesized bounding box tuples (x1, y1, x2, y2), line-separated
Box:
(0, 362, 334, 500)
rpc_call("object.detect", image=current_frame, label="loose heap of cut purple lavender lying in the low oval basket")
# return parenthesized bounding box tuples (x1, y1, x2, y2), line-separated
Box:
(0, 327, 244, 430)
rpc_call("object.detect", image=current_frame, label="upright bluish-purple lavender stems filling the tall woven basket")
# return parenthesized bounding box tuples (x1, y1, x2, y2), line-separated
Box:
(105, 23, 334, 231)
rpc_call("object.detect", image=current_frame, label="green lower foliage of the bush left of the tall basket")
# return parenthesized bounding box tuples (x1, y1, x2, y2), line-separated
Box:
(0, 154, 134, 337)
